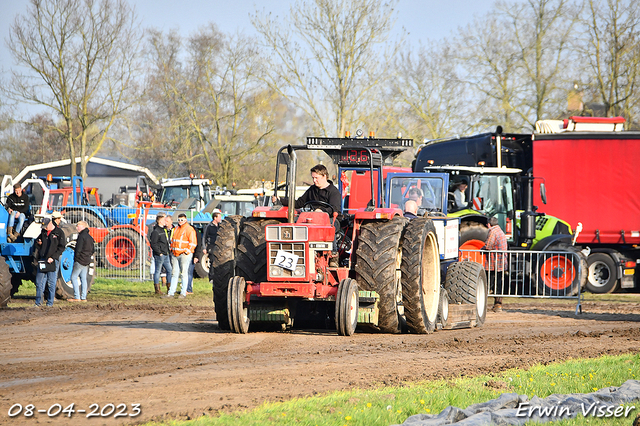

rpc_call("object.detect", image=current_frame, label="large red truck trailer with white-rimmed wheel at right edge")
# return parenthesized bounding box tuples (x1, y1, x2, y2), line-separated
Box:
(532, 117, 640, 293)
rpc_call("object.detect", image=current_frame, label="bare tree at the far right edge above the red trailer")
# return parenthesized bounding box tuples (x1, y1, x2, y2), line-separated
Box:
(580, 0, 640, 122)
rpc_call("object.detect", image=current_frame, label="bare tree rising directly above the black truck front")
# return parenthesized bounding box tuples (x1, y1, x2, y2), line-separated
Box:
(458, 0, 577, 131)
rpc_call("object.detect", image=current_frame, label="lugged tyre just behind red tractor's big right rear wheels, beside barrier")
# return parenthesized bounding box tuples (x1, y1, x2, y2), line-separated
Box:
(444, 261, 488, 327)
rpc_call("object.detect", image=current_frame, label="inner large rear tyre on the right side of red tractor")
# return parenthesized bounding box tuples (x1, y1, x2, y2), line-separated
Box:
(355, 216, 407, 333)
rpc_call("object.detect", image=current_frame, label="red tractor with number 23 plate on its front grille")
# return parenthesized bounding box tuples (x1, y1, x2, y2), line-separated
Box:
(211, 137, 486, 335)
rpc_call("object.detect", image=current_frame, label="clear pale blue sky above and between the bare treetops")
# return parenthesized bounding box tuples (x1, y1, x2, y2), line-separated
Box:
(0, 0, 494, 115)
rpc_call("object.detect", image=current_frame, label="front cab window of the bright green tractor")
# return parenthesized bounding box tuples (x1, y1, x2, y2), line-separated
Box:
(470, 176, 514, 217)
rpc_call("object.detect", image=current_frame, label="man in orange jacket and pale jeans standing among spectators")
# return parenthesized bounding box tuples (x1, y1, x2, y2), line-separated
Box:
(167, 213, 198, 299)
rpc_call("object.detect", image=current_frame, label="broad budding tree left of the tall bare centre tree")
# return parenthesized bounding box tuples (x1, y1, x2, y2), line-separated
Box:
(138, 25, 282, 186)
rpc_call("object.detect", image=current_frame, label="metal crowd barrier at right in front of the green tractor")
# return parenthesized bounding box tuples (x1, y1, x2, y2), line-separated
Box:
(460, 250, 586, 314)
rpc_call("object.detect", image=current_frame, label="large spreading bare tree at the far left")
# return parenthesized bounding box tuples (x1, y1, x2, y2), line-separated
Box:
(6, 0, 142, 176)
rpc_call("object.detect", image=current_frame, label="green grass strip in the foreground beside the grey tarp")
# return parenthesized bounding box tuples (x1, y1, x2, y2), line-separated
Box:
(141, 354, 640, 426)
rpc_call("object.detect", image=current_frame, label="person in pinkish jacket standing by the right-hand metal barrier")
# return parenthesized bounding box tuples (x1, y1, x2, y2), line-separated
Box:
(484, 216, 509, 312)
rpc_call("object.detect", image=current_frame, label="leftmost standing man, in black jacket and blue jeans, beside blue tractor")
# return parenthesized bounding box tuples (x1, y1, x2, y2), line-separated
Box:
(34, 217, 66, 306)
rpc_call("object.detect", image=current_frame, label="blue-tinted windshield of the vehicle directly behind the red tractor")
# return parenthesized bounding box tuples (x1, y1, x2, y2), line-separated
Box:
(389, 176, 444, 212)
